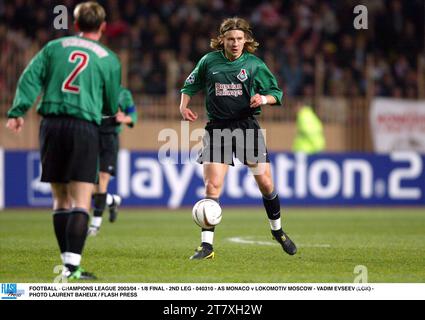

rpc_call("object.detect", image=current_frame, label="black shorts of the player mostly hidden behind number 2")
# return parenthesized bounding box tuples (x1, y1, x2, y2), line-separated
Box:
(99, 132, 119, 176)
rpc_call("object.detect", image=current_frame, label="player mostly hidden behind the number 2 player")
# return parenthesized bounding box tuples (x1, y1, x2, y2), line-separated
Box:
(88, 88, 137, 236)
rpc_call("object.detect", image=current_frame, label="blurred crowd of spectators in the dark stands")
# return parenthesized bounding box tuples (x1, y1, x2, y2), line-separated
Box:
(0, 0, 425, 99)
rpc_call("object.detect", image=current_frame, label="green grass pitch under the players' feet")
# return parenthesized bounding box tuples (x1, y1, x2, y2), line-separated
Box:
(0, 208, 425, 283)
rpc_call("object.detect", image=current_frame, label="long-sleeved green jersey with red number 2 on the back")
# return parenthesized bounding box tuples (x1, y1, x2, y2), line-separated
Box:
(8, 36, 121, 124)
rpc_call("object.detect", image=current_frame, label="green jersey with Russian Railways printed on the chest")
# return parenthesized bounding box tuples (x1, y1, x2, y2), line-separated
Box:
(181, 51, 282, 120)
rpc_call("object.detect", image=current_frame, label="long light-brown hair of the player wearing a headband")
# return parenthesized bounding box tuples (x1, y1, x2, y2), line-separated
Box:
(210, 17, 259, 53)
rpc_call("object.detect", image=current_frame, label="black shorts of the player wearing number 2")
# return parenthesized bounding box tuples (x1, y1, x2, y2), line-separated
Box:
(39, 116, 99, 183)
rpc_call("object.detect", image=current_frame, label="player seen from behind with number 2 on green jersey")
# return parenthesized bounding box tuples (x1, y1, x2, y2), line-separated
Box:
(7, 2, 121, 279)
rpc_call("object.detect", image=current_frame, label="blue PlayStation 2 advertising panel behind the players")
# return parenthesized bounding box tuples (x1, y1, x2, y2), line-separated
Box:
(4, 150, 425, 208)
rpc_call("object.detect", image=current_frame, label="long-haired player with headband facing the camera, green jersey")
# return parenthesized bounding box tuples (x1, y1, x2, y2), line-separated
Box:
(180, 18, 297, 259)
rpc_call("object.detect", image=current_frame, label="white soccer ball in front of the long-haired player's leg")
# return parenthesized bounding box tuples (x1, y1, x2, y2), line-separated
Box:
(192, 199, 222, 229)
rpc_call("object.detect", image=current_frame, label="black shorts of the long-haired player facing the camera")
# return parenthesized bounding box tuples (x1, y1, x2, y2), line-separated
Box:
(198, 117, 270, 166)
